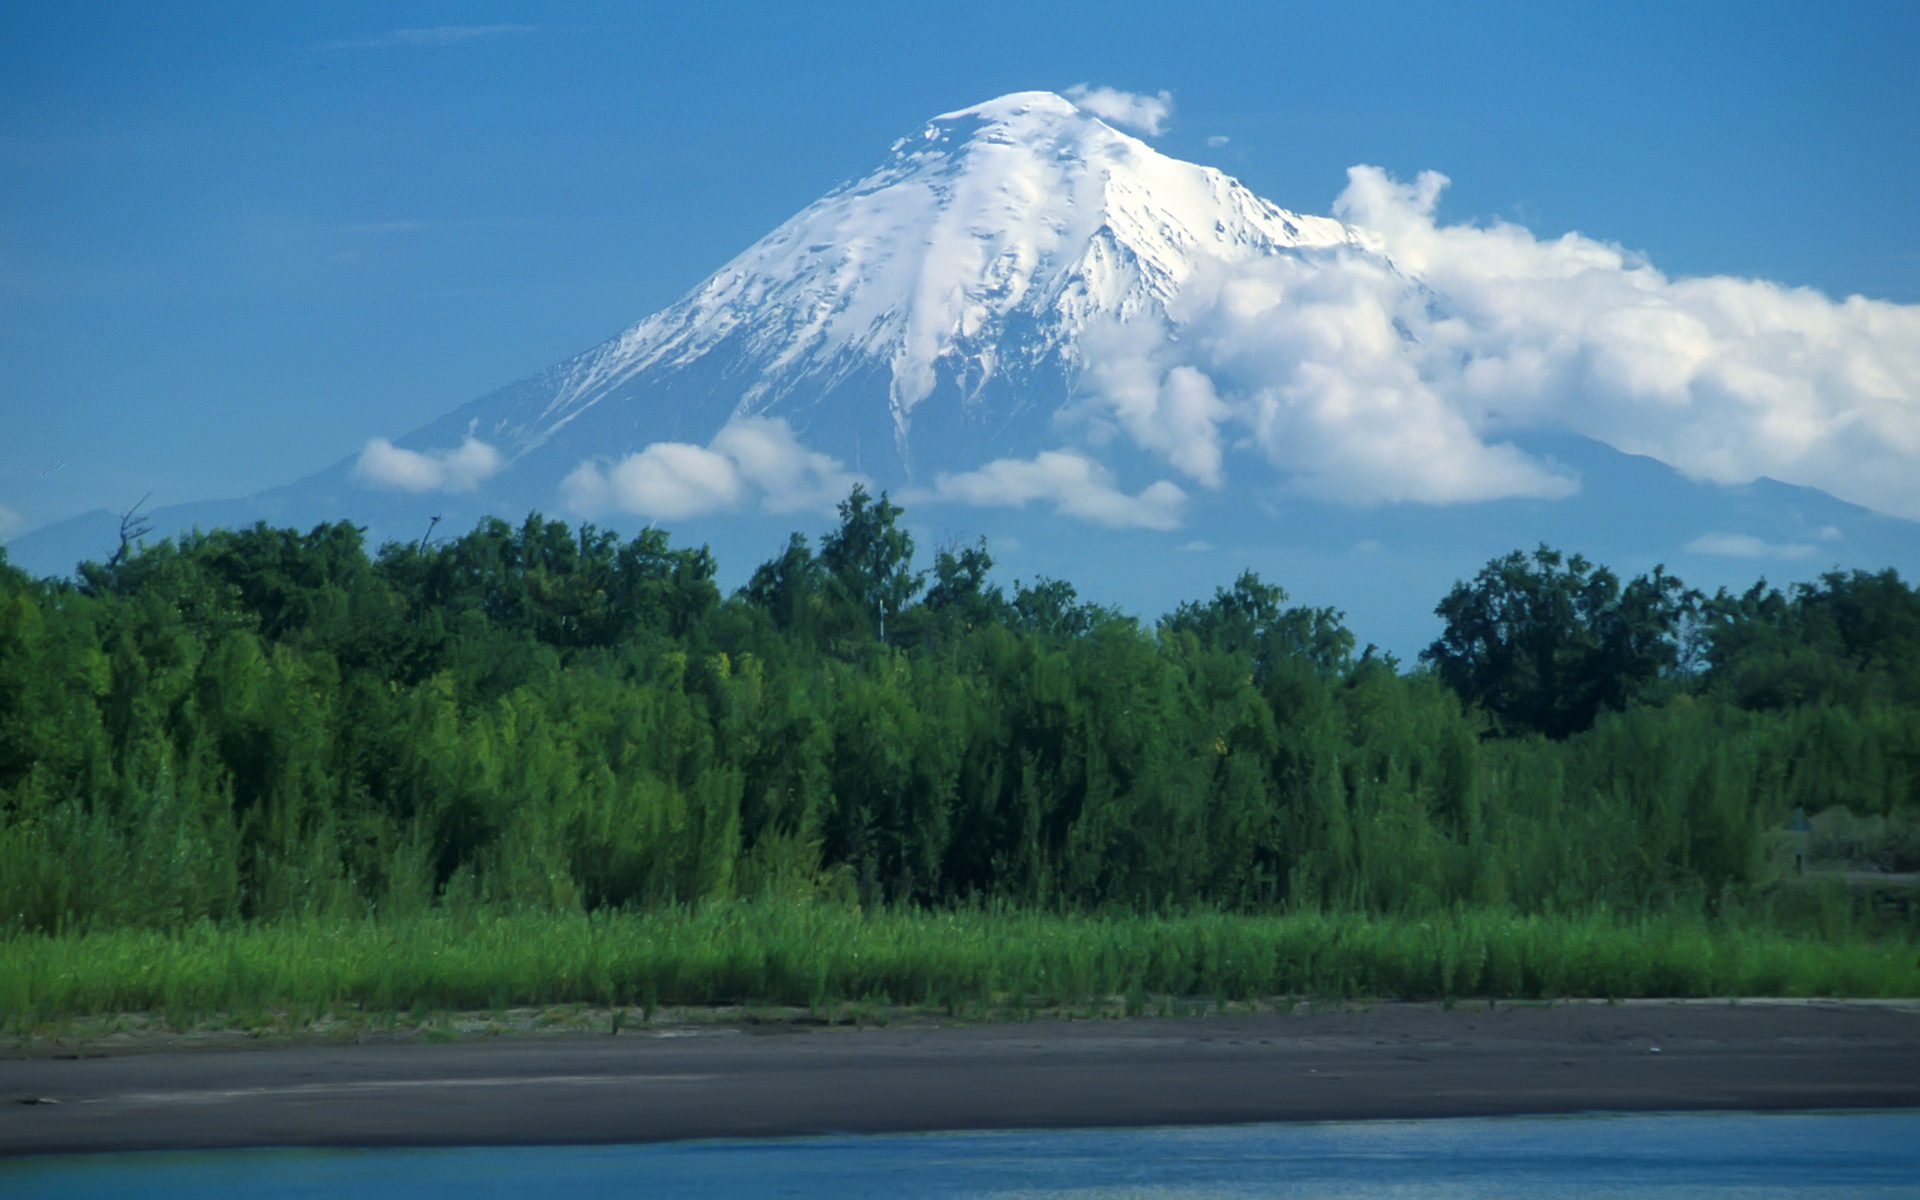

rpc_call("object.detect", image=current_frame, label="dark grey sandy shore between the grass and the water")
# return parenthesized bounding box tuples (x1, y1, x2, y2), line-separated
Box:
(0, 1000, 1920, 1154)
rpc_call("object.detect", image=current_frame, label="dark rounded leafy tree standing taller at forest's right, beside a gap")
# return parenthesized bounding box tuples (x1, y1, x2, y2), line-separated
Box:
(1421, 545, 1697, 737)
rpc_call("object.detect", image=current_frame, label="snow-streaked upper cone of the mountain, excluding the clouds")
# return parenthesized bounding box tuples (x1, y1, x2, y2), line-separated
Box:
(407, 92, 1380, 484)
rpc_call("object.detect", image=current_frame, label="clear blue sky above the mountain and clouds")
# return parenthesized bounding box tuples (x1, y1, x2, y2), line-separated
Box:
(0, 4, 1920, 549)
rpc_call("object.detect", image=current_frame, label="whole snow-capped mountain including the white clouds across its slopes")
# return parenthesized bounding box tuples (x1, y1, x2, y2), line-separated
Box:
(8, 92, 1920, 655)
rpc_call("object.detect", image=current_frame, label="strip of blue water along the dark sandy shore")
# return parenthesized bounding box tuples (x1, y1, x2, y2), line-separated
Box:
(0, 1110, 1920, 1200)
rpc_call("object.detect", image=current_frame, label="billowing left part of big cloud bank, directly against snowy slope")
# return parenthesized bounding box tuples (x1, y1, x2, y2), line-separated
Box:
(1066, 255, 1578, 505)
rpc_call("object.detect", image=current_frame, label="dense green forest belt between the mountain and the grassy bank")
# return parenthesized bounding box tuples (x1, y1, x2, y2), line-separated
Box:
(0, 488, 1920, 1021)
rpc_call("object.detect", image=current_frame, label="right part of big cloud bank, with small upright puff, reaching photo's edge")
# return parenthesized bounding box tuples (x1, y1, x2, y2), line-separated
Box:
(1334, 167, 1920, 516)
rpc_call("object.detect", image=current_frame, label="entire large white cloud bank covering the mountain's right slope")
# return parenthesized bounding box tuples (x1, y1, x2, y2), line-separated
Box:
(1064, 167, 1920, 518)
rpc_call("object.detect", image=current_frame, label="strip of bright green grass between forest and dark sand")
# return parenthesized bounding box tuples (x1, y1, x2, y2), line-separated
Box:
(0, 902, 1920, 1033)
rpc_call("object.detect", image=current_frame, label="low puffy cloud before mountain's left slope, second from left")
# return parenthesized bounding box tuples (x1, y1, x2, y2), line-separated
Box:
(561, 417, 860, 520)
